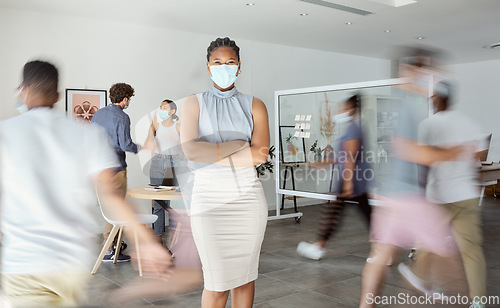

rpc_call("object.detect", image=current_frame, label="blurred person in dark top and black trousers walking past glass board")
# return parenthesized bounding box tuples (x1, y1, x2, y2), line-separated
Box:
(297, 94, 373, 260)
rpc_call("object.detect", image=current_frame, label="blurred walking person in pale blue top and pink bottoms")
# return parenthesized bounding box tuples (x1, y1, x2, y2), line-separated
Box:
(360, 47, 463, 307)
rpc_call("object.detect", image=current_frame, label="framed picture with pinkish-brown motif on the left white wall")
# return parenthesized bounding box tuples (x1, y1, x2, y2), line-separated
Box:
(66, 89, 108, 123)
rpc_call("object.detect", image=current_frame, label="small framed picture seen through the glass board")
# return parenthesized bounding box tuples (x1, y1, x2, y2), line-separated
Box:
(279, 126, 306, 163)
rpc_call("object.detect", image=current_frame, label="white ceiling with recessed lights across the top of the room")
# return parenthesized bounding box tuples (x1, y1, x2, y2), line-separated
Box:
(0, 0, 500, 63)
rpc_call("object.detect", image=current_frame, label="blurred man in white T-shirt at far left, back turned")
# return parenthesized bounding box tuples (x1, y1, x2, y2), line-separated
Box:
(0, 61, 171, 307)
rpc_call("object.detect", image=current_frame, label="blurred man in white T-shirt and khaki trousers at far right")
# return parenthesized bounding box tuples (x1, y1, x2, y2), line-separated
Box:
(399, 81, 487, 307)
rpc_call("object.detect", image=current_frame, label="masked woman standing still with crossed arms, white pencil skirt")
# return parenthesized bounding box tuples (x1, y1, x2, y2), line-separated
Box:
(181, 37, 270, 308)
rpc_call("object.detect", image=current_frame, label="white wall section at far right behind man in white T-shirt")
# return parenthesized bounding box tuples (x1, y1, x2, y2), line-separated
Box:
(452, 60, 500, 162)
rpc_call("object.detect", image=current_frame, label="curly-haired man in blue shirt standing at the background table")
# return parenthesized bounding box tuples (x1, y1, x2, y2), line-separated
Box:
(92, 83, 149, 262)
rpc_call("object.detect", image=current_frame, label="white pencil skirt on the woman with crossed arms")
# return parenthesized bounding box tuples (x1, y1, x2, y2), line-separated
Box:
(190, 167, 267, 291)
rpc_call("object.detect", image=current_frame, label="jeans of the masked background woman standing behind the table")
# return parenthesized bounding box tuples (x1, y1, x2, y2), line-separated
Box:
(149, 154, 178, 235)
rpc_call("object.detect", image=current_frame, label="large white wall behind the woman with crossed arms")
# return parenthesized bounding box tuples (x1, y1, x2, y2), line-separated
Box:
(0, 9, 390, 214)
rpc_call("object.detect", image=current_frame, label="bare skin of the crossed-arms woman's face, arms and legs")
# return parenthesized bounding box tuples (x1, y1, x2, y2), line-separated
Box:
(180, 47, 270, 308)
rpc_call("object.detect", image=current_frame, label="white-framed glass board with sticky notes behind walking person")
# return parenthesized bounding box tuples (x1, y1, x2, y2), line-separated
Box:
(275, 79, 429, 199)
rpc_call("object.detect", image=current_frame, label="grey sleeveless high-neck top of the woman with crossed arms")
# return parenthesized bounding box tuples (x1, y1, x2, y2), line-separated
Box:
(189, 87, 253, 169)
